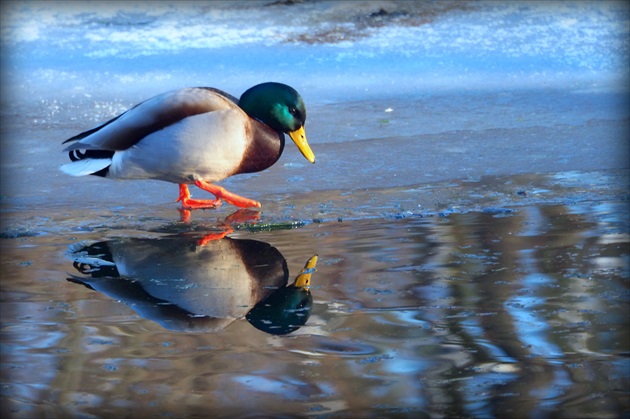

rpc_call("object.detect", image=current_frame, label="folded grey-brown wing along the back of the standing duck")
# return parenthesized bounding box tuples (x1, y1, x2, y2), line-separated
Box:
(63, 87, 238, 151)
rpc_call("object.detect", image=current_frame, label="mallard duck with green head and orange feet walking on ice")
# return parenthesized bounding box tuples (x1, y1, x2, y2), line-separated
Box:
(61, 82, 315, 209)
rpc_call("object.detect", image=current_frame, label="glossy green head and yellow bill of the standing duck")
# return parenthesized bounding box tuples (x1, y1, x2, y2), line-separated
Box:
(238, 82, 315, 163)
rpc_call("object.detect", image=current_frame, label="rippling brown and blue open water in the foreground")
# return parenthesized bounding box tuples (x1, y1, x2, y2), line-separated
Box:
(0, 176, 630, 417)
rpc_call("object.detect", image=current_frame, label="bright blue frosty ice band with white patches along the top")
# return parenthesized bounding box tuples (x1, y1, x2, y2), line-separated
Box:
(3, 1, 628, 96)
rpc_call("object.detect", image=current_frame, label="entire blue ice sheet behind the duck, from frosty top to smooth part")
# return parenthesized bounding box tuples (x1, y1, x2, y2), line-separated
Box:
(0, 1, 630, 212)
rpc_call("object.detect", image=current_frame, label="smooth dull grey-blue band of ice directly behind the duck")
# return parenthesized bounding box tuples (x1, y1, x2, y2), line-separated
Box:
(0, 90, 628, 213)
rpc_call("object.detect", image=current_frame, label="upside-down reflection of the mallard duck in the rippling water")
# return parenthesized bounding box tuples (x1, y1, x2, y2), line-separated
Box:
(68, 212, 317, 335)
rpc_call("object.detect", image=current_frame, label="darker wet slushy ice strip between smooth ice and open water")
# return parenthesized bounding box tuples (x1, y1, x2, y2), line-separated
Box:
(2, 170, 630, 237)
